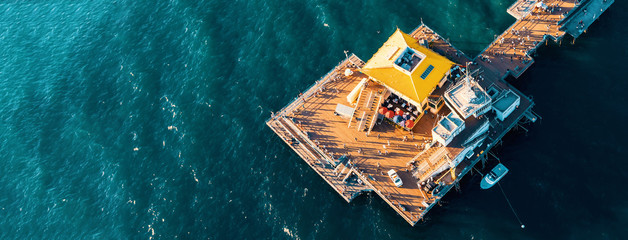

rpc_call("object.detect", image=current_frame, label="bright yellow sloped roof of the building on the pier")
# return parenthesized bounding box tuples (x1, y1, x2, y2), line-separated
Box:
(361, 29, 454, 104)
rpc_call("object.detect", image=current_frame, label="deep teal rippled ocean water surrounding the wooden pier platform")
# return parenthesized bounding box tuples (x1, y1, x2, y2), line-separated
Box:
(0, 0, 628, 239)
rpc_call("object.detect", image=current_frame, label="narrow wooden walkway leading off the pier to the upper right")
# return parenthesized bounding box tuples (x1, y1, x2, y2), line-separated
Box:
(475, 0, 614, 78)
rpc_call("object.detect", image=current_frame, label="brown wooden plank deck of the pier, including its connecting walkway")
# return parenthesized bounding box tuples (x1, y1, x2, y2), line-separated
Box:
(266, 0, 612, 226)
